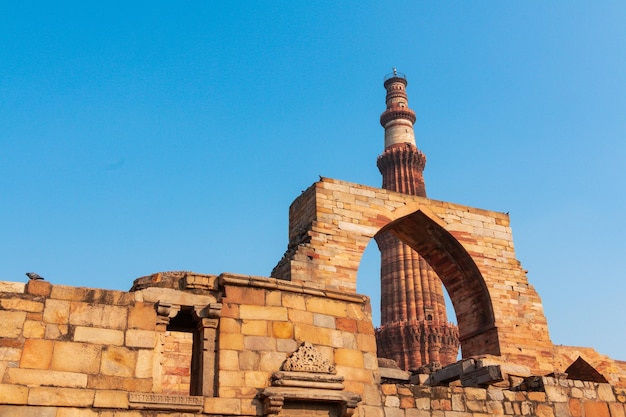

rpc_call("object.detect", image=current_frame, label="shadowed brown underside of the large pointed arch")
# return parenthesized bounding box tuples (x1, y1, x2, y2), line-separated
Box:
(379, 207, 500, 357)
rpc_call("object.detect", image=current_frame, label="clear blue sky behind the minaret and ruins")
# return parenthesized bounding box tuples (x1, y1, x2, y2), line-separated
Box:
(0, 0, 626, 359)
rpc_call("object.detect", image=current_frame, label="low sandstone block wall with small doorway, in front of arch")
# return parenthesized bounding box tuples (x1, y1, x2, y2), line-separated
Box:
(0, 273, 626, 417)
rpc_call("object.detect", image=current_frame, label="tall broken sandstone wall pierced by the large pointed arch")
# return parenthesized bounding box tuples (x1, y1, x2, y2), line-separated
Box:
(274, 178, 553, 372)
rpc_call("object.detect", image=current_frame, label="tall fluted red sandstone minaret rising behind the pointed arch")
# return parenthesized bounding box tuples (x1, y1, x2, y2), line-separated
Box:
(375, 68, 459, 370)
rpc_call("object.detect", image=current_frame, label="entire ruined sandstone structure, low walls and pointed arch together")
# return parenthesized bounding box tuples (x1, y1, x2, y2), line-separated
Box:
(0, 76, 626, 417)
